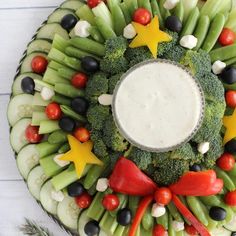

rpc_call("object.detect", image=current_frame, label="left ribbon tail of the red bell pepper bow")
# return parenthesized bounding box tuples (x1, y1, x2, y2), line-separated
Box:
(129, 195, 153, 236)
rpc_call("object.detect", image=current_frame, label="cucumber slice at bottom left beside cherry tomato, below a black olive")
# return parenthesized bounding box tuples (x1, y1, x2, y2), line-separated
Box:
(57, 196, 81, 230)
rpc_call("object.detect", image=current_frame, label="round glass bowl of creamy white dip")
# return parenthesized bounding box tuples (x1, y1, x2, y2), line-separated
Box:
(113, 60, 204, 151)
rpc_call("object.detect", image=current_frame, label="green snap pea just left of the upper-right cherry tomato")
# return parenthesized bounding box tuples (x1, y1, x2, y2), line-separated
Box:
(202, 13, 225, 52)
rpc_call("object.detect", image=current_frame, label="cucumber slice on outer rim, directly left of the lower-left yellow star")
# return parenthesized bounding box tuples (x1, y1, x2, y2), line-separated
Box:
(16, 144, 39, 179)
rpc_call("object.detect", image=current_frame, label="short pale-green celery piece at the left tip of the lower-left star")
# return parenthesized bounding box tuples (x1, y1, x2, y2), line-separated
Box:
(39, 154, 65, 178)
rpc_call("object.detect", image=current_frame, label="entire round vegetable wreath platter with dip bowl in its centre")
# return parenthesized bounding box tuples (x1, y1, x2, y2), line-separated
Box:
(8, 0, 236, 236)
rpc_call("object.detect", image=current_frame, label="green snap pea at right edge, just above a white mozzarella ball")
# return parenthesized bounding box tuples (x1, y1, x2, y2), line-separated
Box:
(210, 43, 236, 62)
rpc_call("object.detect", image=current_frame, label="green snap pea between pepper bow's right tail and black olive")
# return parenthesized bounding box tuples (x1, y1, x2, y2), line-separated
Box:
(186, 196, 208, 226)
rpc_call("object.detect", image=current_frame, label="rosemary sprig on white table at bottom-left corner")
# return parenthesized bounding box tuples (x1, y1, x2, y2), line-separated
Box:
(19, 218, 53, 236)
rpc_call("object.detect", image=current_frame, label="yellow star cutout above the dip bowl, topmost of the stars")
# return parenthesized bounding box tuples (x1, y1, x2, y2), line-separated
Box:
(129, 16, 172, 58)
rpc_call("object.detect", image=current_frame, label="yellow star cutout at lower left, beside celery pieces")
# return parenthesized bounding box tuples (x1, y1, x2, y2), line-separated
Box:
(59, 135, 103, 178)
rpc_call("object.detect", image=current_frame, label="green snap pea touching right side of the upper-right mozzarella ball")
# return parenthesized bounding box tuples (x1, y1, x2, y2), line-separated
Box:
(194, 16, 210, 50)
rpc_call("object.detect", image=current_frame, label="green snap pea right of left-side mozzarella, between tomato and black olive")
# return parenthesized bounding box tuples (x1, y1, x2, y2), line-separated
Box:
(54, 83, 84, 98)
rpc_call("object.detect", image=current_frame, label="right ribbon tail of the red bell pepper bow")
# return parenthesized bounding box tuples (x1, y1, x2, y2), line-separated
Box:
(172, 194, 210, 236)
